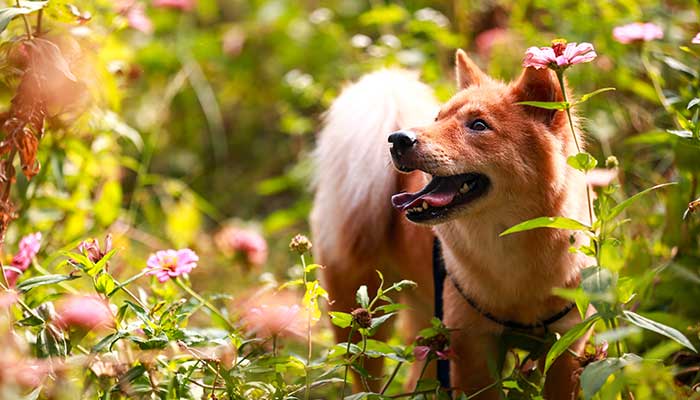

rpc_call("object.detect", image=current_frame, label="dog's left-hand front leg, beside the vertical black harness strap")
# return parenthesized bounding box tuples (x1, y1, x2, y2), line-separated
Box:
(444, 284, 502, 400)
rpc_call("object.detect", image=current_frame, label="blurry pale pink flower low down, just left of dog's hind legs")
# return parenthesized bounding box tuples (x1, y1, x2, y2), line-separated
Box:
(243, 293, 305, 337)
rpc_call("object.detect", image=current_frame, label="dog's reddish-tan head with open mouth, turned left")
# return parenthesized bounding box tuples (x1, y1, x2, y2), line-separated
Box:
(389, 50, 573, 224)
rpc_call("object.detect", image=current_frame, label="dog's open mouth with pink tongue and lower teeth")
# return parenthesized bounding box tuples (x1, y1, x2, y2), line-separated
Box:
(391, 173, 491, 222)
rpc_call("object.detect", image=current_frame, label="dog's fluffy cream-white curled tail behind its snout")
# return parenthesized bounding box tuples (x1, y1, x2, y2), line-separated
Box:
(311, 70, 438, 262)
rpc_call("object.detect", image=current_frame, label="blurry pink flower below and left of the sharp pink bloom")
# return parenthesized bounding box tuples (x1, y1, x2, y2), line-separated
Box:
(56, 295, 114, 329)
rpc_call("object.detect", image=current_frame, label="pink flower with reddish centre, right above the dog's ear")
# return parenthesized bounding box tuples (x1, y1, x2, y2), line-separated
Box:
(523, 39, 597, 69)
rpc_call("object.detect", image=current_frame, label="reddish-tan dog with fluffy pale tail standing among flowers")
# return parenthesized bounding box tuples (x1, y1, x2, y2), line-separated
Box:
(310, 50, 591, 400)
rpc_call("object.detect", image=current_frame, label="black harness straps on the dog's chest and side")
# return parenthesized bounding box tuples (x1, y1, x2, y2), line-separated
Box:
(433, 237, 576, 388)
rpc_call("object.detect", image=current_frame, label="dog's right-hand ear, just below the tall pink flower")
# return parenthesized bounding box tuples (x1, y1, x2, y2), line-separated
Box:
(513, 67, 566, 126)
